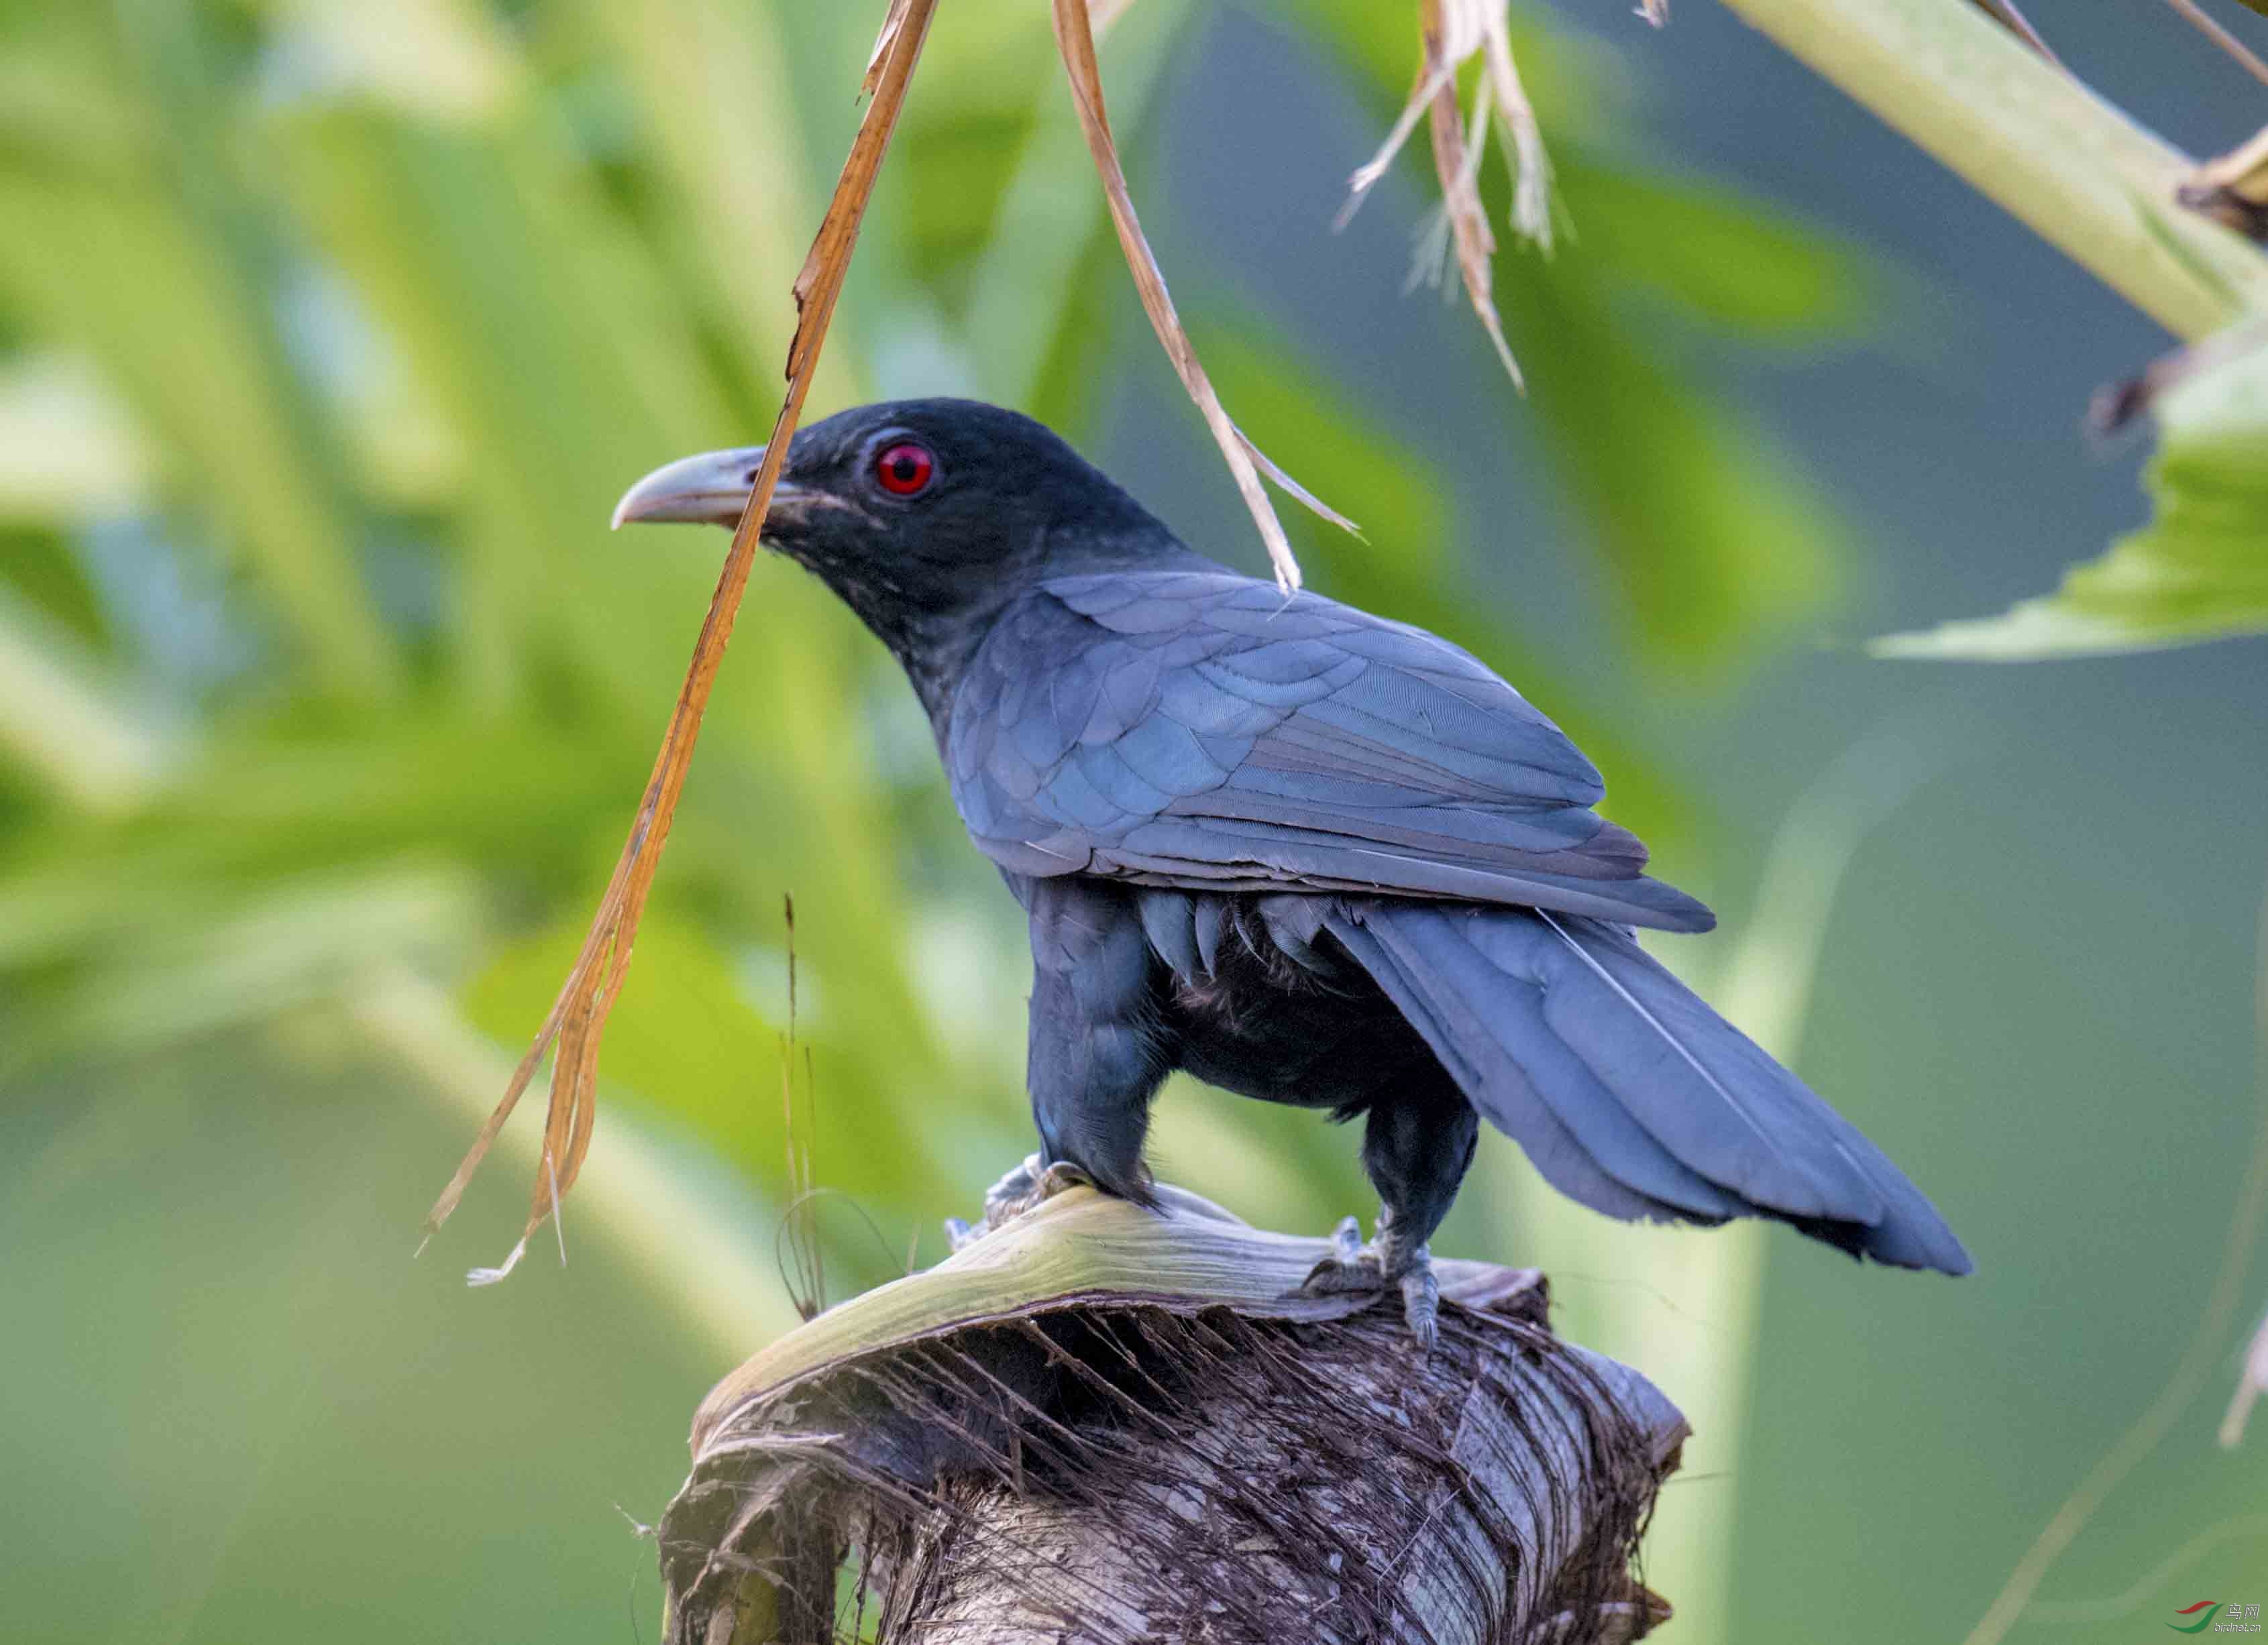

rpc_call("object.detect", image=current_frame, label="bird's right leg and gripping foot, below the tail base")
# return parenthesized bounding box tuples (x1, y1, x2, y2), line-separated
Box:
(1304, 1076, 1478, 1348)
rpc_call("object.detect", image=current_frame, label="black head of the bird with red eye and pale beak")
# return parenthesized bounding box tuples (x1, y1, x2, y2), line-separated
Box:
(614, 399, 1175, 684)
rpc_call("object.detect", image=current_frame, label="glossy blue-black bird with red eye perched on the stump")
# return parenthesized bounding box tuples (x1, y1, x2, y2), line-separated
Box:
(614, 399, 1971, 1339)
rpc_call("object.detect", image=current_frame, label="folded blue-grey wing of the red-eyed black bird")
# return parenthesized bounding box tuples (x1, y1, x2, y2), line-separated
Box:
(946, 569, 1710, 929)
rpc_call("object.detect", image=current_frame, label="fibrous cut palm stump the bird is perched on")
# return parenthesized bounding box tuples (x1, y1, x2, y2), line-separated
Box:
(660, 1187, 1687, 1645)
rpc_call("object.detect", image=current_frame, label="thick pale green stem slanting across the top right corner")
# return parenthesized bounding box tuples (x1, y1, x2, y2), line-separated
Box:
(1726, 0, 2268, 340)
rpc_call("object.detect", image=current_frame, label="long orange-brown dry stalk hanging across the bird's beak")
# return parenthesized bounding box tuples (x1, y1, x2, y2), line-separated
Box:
(424, 0, 936, 1285)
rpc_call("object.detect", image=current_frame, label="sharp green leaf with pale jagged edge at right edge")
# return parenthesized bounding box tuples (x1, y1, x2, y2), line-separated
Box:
(1871, 331, 2268, 662)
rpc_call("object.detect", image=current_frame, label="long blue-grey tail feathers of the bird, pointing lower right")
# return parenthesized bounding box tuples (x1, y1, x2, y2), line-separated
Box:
(1325, 899, 1971, 1273)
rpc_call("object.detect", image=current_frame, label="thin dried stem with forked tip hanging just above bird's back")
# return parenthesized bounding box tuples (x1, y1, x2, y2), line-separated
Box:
(1055, 0, 1354, 593)
